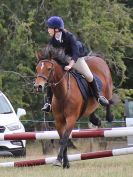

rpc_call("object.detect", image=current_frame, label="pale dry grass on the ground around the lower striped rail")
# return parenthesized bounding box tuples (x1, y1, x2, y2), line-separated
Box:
(0, 142, 133, 177)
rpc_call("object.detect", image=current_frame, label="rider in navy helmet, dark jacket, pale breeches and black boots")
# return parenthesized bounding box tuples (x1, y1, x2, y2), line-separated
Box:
(42, 16, 109, 112)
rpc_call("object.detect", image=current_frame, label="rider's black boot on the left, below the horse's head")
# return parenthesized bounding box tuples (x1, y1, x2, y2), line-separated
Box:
(41, 87, 53, 112)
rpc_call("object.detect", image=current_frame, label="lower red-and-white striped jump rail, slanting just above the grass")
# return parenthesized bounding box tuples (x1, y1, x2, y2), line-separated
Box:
(0, 147, 133, 167)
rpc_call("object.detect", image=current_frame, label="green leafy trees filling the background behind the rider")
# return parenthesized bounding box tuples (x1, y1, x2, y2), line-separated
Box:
(0, 0, 133, 130)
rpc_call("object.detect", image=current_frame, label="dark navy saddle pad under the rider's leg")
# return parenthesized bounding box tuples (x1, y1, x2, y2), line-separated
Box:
(70, 70, 102, 102)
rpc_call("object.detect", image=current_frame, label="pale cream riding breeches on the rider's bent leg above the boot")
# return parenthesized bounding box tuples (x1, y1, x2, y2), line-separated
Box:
(72, 57, 93, 82)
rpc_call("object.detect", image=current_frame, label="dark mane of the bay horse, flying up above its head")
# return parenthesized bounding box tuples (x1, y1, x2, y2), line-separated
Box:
(37, 45, 68, 64)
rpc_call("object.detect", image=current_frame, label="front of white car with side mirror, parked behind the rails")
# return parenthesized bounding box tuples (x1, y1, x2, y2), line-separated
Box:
(0, 91, 26, 156)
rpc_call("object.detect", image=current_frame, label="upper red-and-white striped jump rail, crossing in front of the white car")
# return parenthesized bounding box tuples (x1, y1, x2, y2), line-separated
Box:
(0, 127, 133, 140)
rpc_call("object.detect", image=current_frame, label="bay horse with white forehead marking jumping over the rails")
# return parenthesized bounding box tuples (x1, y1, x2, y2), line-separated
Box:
(34, 46, 113, 168)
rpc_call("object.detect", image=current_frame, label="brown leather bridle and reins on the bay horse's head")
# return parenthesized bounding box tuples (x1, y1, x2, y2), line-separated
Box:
(36, 60, 68, 87)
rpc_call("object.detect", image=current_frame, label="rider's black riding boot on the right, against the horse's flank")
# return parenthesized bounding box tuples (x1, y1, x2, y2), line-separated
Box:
(89, 78, 109, 106)
